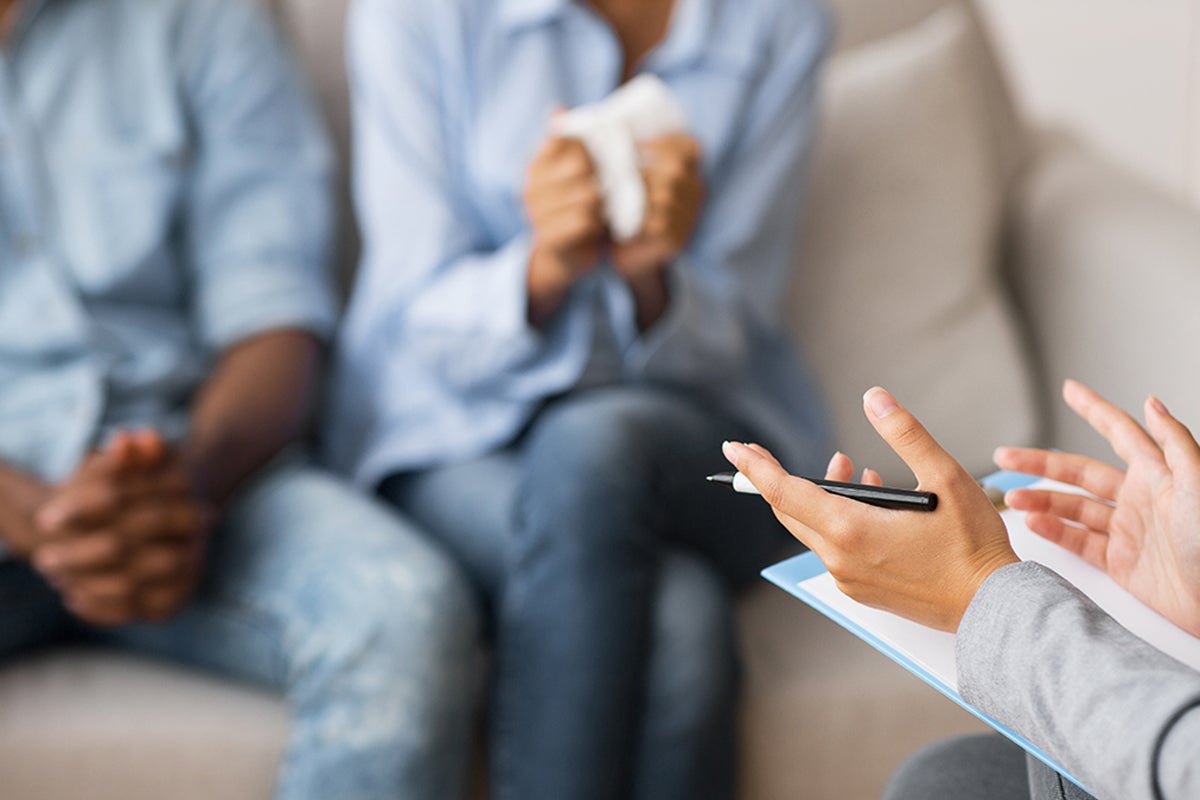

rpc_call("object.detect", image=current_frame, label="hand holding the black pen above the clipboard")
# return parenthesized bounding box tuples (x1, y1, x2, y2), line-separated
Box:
(725, 389, 1018, 631)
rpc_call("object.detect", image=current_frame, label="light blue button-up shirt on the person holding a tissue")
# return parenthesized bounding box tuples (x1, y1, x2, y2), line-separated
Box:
(329, 0, 830, 485)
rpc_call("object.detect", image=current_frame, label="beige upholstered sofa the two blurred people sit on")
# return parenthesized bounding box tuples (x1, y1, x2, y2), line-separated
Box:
(0, 0, 1200, 800)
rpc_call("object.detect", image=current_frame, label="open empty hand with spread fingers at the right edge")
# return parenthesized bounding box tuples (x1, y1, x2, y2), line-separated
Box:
(996, 380, 1200, 636)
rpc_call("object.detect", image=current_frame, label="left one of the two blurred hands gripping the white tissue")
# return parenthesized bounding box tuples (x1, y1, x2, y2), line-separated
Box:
(523, 137, 608, 324)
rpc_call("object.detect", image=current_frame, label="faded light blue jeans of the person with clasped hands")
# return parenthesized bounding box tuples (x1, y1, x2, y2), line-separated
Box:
(0, 465, 480, 800)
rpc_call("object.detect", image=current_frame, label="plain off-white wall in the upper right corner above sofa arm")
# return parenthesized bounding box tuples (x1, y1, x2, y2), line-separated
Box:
(982, 0, 1200, 207)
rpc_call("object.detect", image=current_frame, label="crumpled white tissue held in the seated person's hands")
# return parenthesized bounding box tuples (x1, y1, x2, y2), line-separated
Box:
(554, 74, 688, 241)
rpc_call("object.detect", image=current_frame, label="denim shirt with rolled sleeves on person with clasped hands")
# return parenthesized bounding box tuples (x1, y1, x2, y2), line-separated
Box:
(0, 0, 335, 481)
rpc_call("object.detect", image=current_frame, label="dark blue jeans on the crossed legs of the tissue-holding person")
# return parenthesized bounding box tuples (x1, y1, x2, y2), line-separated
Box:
(382, 387, 786, 800)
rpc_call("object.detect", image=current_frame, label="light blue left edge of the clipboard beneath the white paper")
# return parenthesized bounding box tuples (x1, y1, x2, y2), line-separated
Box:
(762, 553, 1087, 792)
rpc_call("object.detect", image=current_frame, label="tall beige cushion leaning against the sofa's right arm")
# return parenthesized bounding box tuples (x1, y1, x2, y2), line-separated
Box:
(790, 4, 1038, 482)
